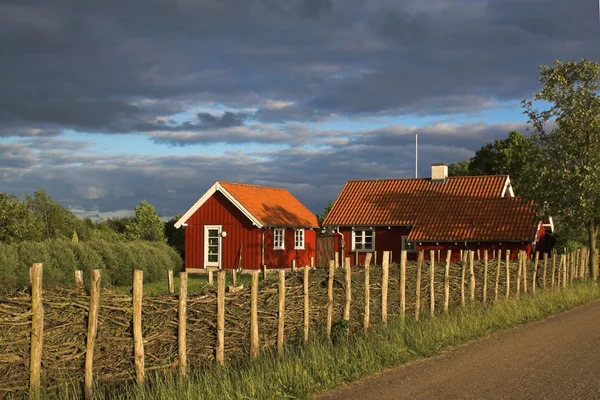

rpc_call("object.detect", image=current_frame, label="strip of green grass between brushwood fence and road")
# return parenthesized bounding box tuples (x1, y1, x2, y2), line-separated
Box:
(61, 282, 600, 399)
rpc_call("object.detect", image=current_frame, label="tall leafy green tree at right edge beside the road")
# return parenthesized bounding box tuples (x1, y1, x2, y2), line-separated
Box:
(522, 59, 600, 279)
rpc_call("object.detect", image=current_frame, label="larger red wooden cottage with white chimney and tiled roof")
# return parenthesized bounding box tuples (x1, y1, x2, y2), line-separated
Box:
(323, 164, 546, 265)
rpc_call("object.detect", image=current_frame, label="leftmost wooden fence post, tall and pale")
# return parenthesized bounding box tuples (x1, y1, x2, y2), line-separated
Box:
(29, 263, 44, 399)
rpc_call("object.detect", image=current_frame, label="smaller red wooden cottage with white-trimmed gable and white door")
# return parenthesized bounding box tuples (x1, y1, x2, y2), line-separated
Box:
(175, 182, 319, 272)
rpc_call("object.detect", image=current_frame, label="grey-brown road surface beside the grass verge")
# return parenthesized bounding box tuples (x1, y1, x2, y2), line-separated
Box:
(316, 300, 600, 400)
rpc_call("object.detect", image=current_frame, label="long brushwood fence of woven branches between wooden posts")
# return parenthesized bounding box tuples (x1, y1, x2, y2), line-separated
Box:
(0, 249, 589, 398)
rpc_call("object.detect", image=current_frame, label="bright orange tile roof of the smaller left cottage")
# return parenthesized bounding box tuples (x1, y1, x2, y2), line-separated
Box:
(219, 182, 319, 228)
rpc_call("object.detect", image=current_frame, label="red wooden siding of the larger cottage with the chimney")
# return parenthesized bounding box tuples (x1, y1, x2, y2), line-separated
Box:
(334, 227, 545, 266)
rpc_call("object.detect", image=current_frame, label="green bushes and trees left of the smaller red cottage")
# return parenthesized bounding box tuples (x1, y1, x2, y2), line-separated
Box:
(0, 189, 183, 291)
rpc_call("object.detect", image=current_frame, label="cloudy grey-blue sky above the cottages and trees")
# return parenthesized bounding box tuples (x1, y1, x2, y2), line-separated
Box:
(0, 0, 600, 219)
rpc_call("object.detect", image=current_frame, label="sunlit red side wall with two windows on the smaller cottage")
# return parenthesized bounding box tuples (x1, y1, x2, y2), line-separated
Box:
(264, 228, 317, 268)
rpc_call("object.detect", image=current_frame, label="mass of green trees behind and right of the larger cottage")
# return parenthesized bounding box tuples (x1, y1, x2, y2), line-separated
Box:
(449, 59, 600, 278)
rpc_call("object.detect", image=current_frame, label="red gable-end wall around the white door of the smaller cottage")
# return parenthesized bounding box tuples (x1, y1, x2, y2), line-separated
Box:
(185, 192, 261, 269)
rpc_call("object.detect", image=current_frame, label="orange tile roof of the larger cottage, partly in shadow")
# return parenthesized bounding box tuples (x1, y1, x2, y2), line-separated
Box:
(323, 175, 537, 241)
